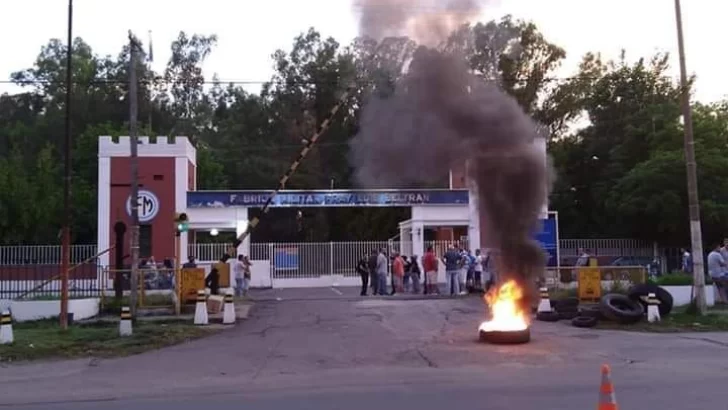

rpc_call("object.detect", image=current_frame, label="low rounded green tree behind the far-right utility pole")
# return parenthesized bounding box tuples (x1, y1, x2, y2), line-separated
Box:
(607, 103, 728, 246)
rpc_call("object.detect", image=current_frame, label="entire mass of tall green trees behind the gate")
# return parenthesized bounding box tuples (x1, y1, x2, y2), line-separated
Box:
(0, 21, 728, 245)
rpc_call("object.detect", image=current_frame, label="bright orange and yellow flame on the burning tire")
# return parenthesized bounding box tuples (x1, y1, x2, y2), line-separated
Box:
(479, 280, 528, 332)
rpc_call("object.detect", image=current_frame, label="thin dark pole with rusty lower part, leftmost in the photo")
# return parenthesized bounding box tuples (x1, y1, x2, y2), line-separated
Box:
(60, 0, 73, 330)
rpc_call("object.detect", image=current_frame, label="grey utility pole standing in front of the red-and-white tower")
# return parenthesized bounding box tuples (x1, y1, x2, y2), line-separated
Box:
(129, 30, 139, 317)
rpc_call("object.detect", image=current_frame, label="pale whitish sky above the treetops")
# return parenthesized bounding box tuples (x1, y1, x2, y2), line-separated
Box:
(0, 0, 728, 102)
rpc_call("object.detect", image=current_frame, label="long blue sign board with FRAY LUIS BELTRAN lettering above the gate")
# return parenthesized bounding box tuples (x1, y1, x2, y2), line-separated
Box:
(187, 189, 468, 208)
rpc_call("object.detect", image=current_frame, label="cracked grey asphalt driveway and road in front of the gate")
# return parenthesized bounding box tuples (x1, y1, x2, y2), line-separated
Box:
(0, 289, 728, 410)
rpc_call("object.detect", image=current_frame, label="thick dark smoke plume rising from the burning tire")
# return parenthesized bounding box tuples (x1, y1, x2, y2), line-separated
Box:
(351, 0, 551, 288)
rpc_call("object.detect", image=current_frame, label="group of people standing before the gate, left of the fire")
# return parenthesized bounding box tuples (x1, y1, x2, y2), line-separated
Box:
(356, 245, 495, 296)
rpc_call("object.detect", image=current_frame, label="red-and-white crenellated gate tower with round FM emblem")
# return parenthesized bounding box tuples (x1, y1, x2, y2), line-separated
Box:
(98, 136, 197, 266)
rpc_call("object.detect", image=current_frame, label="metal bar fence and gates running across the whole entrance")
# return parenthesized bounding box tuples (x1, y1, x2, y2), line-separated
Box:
(0, 239, 665, 297)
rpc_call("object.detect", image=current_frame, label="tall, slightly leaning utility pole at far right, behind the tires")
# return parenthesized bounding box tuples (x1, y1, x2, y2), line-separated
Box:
(675, 0, 707, 315)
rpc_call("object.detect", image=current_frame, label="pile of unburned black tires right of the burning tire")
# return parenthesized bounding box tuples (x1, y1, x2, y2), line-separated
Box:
(536, 284, 673, 327)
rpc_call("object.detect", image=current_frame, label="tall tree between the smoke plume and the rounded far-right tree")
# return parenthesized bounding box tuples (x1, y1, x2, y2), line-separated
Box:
(551, 54, 681, 240)
